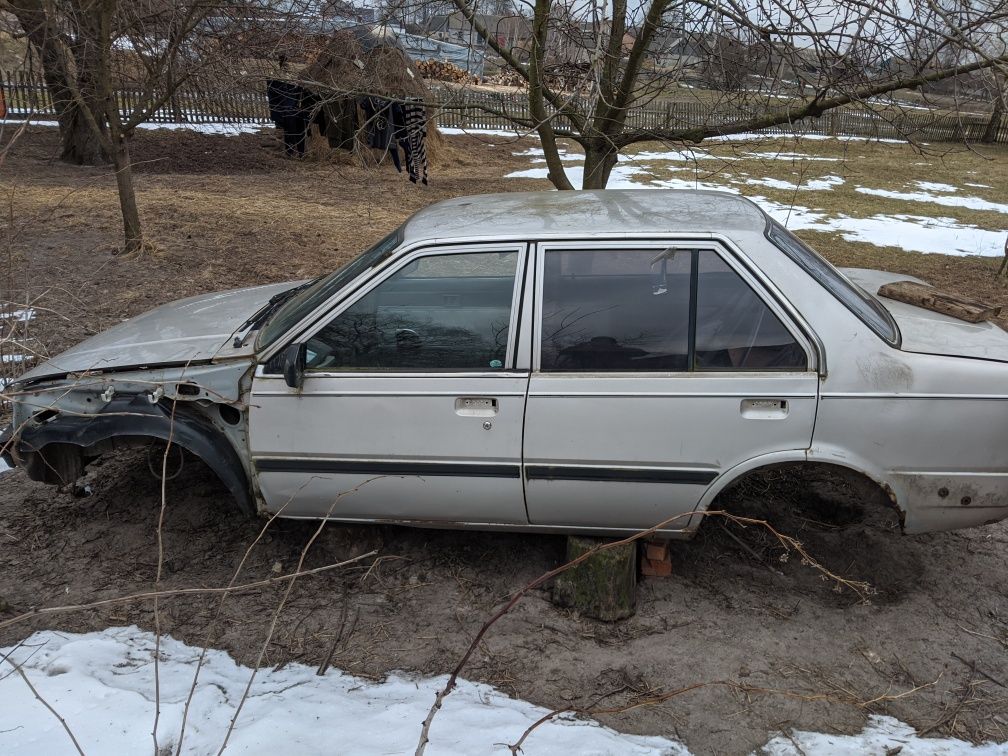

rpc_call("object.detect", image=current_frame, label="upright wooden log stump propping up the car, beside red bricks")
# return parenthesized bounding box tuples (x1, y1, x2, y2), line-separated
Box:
(553, 535, 637, 622)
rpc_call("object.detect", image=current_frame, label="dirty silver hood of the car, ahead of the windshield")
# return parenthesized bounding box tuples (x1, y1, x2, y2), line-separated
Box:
(18, 283, 295, 381)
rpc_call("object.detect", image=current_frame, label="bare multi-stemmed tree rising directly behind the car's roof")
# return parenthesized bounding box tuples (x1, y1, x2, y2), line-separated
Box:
(435, 0, 1008, 190)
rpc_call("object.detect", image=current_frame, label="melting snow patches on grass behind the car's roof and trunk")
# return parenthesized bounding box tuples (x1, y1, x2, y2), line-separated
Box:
(508, 146, 1008, 256)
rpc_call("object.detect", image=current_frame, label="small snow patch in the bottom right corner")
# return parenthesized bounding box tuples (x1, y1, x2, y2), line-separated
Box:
(761, 715, 1005, 756)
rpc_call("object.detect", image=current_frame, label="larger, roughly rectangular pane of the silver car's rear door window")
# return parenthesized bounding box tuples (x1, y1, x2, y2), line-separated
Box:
(541, 249, 690, 371)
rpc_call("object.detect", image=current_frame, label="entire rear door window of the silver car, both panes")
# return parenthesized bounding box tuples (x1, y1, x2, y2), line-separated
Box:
(539, 248, 807, 372)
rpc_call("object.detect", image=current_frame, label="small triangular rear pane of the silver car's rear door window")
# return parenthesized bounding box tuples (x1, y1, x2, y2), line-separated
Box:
(696, 250, 806, 370)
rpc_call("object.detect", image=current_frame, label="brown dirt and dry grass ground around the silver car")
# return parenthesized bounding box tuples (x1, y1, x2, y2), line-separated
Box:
(0, 130, 1008, 754)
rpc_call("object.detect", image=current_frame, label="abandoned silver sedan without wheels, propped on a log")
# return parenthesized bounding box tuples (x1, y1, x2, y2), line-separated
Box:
(3, 191, 1008, 536)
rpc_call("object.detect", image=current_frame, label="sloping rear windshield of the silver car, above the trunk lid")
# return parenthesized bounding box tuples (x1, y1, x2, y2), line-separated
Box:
(764, 216, 902, 349)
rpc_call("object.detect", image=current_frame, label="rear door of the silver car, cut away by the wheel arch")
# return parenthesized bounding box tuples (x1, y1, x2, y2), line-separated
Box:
(524, 241, 818, 530)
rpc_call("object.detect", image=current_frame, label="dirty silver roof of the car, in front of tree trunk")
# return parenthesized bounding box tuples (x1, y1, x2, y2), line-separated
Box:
(403, 190, 767, 241)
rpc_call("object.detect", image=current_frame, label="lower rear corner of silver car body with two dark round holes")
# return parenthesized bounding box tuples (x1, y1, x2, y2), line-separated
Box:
(893, 473, 1008, 533)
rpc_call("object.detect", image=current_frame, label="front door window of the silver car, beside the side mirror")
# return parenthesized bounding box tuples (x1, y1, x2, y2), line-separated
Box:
(307, 251, 518, 371)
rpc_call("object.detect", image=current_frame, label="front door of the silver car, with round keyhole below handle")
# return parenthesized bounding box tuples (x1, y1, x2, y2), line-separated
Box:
(249, 243, 528, 524)
